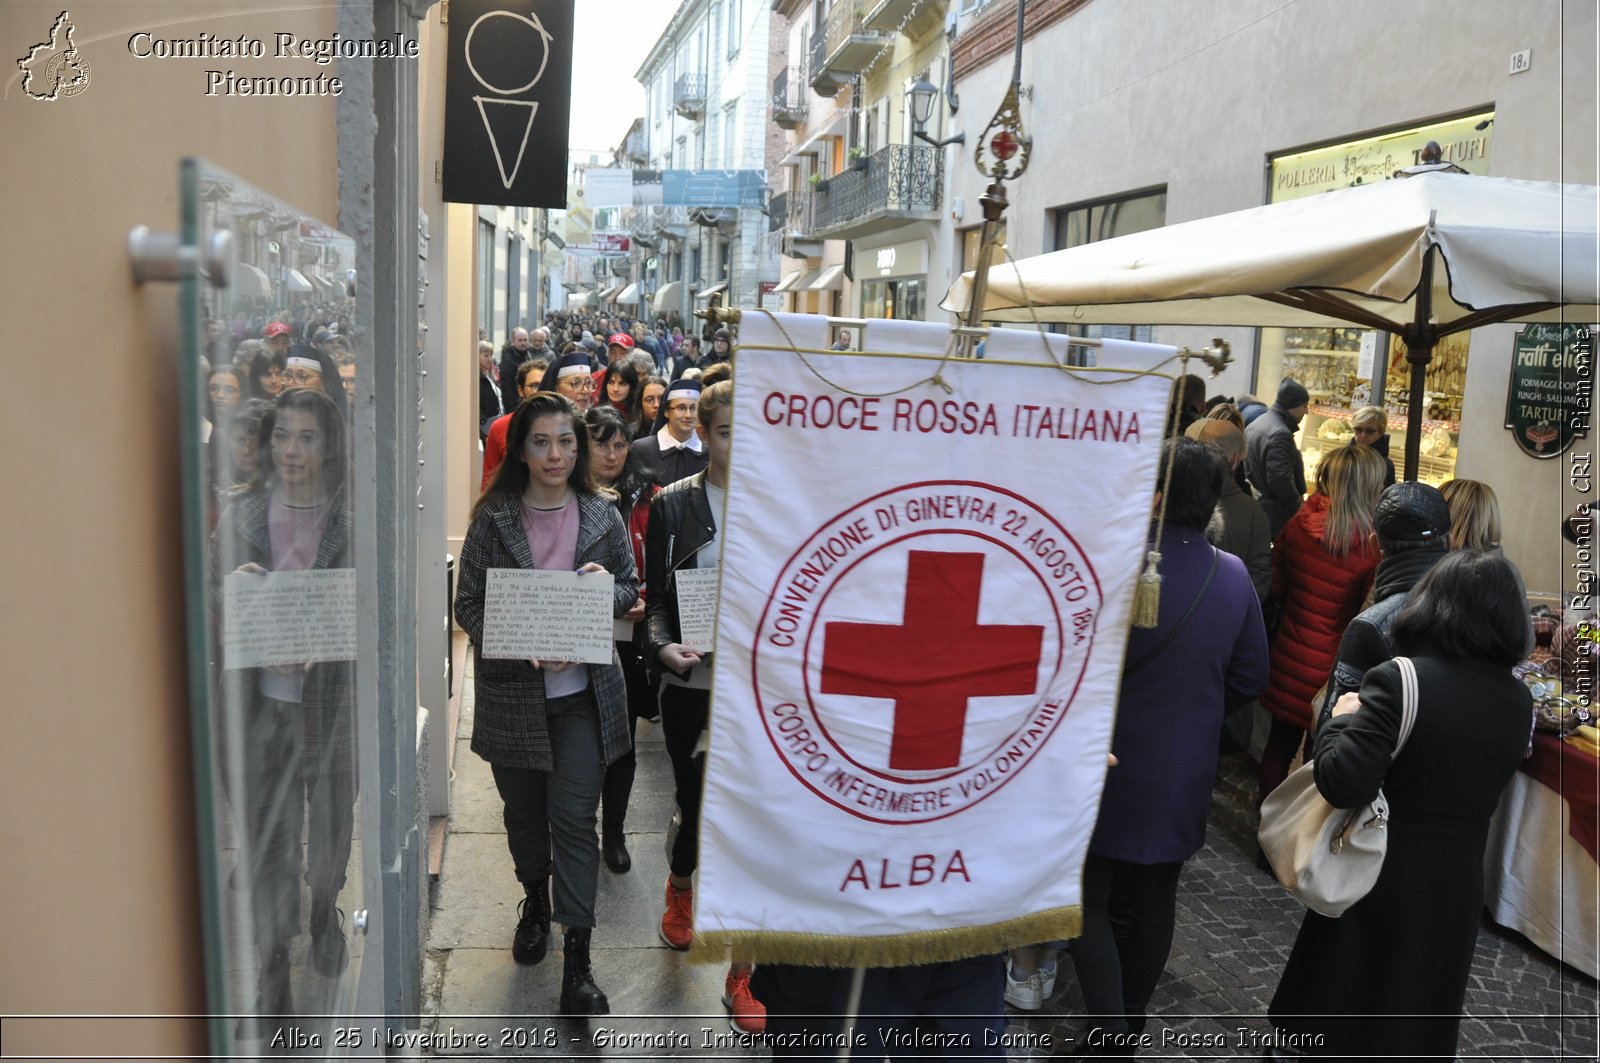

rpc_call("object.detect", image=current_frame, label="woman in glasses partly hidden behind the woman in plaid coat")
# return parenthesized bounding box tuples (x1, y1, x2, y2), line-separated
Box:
(584, 407, 661, 874)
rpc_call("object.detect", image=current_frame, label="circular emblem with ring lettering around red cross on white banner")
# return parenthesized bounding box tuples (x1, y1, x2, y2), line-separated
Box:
(750, 480, 1102, 823)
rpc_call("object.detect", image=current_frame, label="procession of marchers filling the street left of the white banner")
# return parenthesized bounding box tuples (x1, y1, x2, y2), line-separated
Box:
(456, 315, 766, 1034)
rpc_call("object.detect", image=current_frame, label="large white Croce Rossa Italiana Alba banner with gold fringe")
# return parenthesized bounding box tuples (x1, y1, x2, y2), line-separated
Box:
(694, 311, 1176, 965)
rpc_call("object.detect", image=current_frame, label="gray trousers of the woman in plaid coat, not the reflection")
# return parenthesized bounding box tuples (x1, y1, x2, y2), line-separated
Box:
(490, 690, 605, 927)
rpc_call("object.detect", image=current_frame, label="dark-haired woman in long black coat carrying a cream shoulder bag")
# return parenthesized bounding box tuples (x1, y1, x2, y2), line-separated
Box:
(1269, 549, 1533, 1060)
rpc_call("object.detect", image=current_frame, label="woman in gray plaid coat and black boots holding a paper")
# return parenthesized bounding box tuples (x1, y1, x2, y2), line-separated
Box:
(456, 392, 638, 1015)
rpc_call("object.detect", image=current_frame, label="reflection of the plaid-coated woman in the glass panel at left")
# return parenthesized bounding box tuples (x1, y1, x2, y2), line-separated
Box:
(213, 387, 355, 1015)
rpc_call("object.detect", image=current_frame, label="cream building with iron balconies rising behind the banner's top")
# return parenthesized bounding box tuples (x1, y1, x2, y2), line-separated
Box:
(771, 0, 958, 320)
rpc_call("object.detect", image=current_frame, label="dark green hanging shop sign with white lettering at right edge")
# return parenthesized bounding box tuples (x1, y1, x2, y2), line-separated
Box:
(1506, 325, 1594, 458)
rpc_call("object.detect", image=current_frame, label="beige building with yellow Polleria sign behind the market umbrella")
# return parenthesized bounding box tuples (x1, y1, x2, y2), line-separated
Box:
(930, 0, 1597, 591)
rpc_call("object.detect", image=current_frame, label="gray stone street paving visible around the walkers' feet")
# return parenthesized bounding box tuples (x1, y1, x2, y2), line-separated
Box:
(422, 664, 1600, 1060)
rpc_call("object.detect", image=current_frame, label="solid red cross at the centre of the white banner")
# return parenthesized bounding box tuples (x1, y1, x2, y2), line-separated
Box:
(821, 551, 1045, 772)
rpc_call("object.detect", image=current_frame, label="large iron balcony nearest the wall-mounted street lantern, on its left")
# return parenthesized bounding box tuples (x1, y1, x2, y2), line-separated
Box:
(814, 144, 944, 240)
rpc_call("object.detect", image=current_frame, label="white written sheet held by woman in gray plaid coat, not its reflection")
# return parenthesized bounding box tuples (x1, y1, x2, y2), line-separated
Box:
(483, 568, 616, 664)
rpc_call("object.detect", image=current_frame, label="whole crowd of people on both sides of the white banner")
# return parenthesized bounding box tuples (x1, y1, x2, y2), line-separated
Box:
(456, 328, 1531, 1058)
